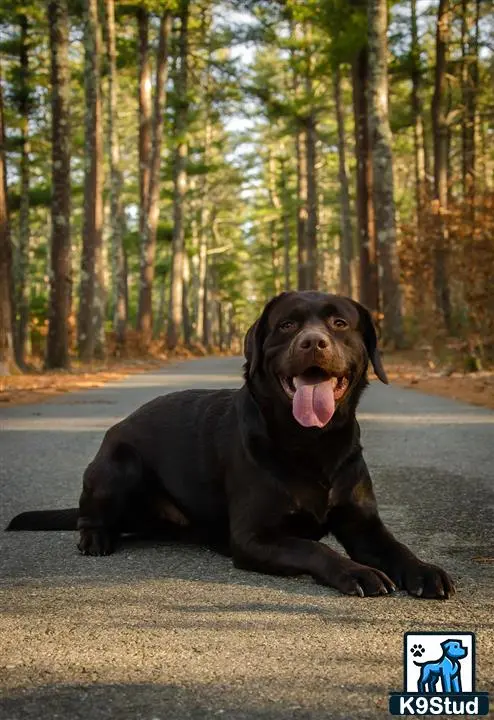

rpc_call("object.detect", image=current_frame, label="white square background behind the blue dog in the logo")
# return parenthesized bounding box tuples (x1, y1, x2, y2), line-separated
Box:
(405, 633, 474, 692)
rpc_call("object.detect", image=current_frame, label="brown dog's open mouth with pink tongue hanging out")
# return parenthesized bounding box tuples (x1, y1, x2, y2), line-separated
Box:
(280, 366, 350, 428)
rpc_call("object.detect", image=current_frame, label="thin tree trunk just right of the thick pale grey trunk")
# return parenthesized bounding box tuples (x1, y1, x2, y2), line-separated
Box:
(411, 0, 428, 228)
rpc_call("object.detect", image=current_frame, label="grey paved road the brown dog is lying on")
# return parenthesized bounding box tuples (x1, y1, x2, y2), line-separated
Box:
(0, 358, 494, 720)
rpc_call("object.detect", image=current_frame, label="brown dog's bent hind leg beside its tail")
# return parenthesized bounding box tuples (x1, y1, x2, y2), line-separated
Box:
(77, 444, 143, 555)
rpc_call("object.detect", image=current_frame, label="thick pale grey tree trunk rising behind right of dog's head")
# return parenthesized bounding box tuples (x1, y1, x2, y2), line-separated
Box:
(368, 0, 403, 347)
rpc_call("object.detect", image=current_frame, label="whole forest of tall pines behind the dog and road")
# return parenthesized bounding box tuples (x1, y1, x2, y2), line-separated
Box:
(0, 0, 494, 374)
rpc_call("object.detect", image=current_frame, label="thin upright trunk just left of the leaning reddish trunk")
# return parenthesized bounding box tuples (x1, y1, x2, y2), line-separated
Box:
(137, 7, 152, 248)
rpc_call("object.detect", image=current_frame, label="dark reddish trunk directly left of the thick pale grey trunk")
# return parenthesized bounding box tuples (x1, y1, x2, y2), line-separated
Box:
(352, 48, 379, 313)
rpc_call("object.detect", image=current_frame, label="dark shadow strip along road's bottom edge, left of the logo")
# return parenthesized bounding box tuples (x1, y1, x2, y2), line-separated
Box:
(0, 678, 385, 720)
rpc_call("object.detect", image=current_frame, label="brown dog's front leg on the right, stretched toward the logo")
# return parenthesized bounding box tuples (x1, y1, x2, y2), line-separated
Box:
(328, 460, 455, 599)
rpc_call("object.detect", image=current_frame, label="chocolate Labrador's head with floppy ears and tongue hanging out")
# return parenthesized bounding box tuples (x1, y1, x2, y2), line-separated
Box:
(244, 292, 388, 428)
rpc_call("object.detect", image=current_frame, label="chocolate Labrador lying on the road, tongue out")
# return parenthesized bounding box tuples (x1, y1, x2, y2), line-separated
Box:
(7, 291, 455, 599)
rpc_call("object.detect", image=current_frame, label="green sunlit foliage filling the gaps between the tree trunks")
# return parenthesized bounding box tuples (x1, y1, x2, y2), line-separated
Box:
(0, 0, 494, 352)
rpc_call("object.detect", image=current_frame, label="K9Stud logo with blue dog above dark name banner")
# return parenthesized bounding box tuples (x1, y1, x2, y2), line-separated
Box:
(389, 631, 489, 715)
